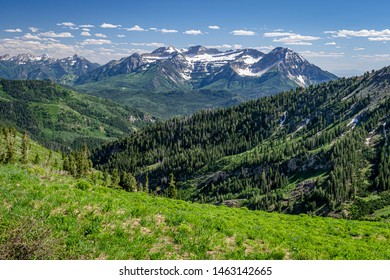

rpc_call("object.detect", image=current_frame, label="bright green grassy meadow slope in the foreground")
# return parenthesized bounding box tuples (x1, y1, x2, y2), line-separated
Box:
(0, 165, 390, 259)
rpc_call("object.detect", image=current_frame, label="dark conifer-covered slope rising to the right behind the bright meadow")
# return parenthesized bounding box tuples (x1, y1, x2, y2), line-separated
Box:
(92, 65, 390, 219)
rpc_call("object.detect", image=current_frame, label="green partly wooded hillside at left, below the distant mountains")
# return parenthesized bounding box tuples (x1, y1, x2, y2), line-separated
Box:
(0, 79, 153, 149)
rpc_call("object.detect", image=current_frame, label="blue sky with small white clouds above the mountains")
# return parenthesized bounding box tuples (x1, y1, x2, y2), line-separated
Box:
(0, 0, 390, 75)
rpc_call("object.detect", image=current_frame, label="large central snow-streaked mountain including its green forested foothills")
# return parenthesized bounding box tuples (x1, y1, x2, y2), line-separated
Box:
(75, 46, 337, 118)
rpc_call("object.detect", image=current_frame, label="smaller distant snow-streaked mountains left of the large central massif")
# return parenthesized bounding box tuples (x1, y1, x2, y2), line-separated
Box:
(0, 54, 100, 85)
